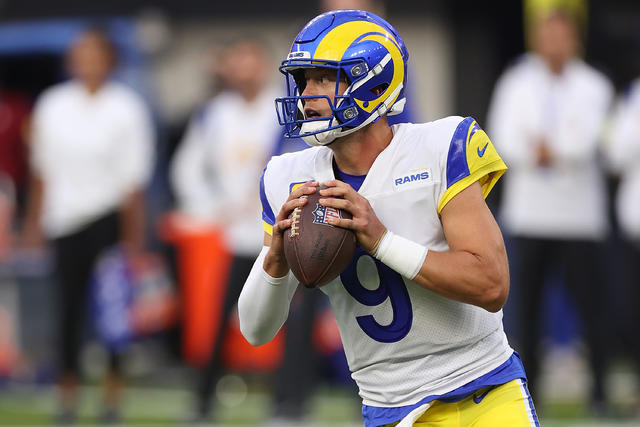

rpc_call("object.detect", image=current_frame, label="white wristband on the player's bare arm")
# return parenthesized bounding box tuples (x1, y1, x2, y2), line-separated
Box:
(373, 230, 429, 279)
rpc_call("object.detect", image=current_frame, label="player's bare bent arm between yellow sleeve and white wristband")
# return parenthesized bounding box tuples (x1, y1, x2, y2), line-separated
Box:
(413, 182, 509, 312)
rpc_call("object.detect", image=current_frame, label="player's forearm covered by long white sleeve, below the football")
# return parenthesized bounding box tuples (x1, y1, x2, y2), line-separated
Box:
(238, 247, 296, 345)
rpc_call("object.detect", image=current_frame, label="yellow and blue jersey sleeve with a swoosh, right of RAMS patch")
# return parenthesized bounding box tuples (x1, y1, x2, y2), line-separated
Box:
(438, 117, 507, 213)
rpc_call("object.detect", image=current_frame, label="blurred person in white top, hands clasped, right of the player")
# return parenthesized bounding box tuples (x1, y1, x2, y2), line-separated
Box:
(488, 5, 613, 405)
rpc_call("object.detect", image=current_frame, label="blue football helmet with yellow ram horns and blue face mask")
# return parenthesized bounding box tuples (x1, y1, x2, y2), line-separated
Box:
(276, 10, 409, 146)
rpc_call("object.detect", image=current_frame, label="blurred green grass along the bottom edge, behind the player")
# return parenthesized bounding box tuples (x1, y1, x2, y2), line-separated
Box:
(0, 386, 640, 427)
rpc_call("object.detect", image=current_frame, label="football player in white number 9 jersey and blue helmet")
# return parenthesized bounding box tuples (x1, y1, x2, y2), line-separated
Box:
(238, 10, 538, 427)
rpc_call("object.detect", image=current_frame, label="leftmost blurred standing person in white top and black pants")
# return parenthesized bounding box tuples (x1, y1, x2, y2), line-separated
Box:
(23, 28, 154, 423)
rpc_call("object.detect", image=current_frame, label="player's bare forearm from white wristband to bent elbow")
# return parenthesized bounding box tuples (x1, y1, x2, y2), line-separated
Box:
(413, 250, 509, 312)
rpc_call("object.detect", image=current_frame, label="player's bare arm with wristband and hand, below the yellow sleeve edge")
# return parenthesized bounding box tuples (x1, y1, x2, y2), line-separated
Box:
(320, 181, 509, 312)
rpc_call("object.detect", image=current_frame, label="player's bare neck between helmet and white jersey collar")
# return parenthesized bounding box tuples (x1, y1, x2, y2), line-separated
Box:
(329, 117, 393, 175)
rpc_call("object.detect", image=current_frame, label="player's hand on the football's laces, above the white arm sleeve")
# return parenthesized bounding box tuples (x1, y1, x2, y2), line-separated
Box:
(263, 181, 318, 277)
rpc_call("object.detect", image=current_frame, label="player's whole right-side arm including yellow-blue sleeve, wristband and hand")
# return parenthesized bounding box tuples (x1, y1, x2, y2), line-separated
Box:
(320, 117, 509, 311)
